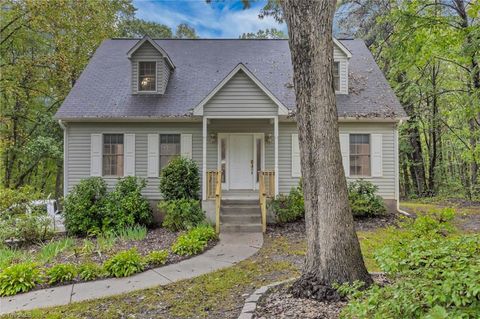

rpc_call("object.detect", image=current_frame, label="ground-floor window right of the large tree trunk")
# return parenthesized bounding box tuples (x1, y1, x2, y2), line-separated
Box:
(350, 134, 370, 176)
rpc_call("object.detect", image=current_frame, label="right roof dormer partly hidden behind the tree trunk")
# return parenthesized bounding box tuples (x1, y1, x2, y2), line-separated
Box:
(333, 39, 352, 94)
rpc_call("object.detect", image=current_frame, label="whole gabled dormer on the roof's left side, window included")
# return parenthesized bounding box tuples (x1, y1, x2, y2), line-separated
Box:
(127, 36, 175, 95)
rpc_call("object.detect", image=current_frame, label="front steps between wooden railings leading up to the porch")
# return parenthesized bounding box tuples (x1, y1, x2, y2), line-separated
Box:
(220, 199, 262, 233)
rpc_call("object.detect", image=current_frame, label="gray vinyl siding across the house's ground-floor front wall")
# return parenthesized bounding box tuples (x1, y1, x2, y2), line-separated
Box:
(65, 119, 396, 199)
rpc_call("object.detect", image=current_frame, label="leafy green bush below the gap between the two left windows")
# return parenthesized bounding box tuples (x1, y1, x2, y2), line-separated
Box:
(102, 176, 152, 232)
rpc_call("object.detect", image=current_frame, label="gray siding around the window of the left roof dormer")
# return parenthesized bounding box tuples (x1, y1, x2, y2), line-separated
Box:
(131, 41, 170, 94)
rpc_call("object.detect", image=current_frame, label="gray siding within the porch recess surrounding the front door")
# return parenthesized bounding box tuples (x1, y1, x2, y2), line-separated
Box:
(207, 119, 275, 174)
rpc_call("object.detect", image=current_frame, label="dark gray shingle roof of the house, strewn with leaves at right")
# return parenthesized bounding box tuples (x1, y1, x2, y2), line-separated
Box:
(56, 39, 405, 119)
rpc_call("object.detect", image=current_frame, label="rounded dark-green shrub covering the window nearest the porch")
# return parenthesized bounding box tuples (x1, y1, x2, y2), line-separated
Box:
(160, 157, 200, 200)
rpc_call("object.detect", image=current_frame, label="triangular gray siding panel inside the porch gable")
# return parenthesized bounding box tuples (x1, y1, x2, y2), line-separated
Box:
(203, 71, 278, 116)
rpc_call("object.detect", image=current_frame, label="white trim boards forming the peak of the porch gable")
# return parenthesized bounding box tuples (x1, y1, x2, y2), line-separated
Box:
(193, 63, 288, 116)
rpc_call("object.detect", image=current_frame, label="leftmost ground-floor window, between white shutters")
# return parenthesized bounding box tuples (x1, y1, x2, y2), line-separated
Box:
(103, 134, 123, 176)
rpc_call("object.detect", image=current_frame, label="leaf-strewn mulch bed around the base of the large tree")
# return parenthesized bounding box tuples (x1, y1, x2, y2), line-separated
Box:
(253, 274, 388, 319)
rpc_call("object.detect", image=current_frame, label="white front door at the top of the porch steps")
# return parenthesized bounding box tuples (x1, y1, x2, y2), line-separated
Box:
(229, 134, 254, 189)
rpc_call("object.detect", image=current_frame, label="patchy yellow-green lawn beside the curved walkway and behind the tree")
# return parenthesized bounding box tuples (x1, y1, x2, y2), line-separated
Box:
(4, 203, 480, 318)
